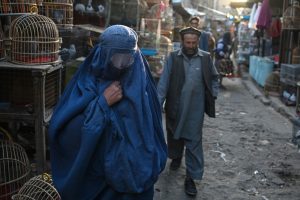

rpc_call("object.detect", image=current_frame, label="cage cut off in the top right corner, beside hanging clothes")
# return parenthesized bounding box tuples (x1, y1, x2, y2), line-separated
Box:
(282, 1, 300, 30)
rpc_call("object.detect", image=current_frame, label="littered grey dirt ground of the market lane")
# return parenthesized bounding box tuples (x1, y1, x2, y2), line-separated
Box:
(154, 78, 300, 200)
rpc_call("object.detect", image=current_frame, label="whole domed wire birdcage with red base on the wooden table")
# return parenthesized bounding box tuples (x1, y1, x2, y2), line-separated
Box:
(8, 14, 60, 65)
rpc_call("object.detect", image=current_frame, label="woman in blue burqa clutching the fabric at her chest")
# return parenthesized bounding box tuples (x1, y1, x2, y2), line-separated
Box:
(49, 25, 167, 200)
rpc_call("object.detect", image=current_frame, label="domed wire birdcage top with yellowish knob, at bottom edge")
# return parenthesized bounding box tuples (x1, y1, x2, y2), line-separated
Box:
(12, 173, 61, 200)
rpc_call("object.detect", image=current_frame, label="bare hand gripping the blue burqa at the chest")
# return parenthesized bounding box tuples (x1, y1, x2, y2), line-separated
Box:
(103, 81, 123, 106)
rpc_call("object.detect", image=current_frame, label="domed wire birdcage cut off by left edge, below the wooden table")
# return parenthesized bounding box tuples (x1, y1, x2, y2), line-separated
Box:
(0, 140, 31, 200)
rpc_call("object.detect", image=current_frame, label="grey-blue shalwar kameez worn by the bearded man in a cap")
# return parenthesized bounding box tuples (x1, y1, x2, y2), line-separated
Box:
(158, 49, 218, 179)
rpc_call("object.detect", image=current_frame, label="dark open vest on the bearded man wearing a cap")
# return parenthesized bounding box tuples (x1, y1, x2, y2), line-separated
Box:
(165, 51, 215, 130)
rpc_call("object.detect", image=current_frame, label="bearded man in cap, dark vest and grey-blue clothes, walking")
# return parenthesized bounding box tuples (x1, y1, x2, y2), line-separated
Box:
(157, 27, 218, 196)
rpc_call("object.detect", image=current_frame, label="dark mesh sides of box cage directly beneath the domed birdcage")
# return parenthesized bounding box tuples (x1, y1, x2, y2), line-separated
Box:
(0, 65, 62, 121)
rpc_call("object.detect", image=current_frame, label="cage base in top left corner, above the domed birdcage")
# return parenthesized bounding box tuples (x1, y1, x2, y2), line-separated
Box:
(0, 0, 37, 15)
